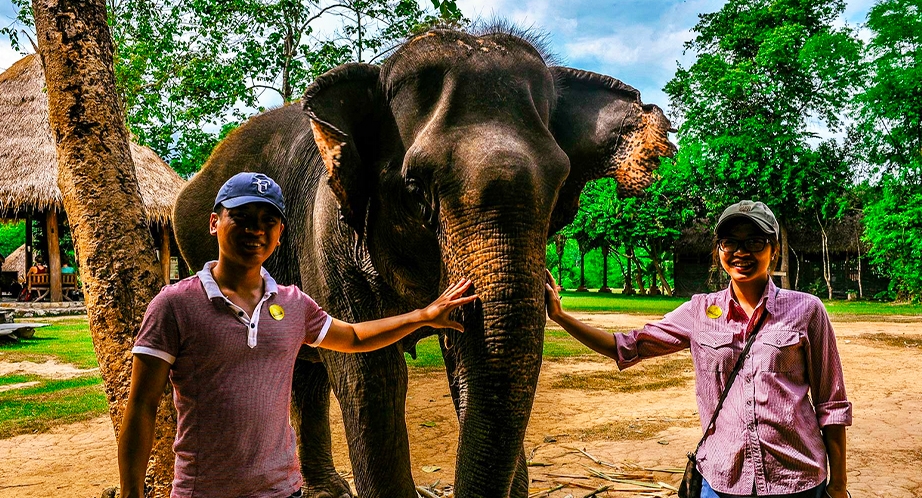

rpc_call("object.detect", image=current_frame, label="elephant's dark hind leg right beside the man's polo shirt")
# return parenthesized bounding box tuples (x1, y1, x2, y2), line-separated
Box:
(291, 360, 352, 498)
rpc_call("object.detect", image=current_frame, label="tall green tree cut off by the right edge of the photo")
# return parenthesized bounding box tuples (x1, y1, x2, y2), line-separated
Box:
(855, 0, 922, 300)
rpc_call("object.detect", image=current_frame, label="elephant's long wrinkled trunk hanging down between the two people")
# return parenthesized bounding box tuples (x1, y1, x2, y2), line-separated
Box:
(444, 207, 548, 498)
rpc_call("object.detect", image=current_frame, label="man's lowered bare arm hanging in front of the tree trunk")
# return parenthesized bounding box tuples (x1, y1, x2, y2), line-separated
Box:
(118, 354, 170, 498)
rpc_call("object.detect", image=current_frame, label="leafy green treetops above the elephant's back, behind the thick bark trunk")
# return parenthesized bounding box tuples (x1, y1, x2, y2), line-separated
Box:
(8, 0, 465, 176)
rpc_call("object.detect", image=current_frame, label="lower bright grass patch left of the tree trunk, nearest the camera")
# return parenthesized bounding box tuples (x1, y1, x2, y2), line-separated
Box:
(0, 375, 109, 439)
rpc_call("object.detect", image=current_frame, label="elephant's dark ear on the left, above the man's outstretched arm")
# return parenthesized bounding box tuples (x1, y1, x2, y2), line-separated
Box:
(304, 64, 393, 237)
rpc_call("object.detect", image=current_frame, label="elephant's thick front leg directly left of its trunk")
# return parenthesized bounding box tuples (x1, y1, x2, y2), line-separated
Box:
(320, 347, 417, 498)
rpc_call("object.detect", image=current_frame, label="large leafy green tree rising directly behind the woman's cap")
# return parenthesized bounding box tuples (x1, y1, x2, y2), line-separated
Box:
(665, 0, 863, 288)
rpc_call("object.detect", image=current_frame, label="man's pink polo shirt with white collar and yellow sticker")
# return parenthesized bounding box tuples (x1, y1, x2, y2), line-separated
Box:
(132, 261, 332, 498)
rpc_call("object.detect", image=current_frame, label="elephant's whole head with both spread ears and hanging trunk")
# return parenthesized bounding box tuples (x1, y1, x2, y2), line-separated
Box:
(304, 30, 675, 496)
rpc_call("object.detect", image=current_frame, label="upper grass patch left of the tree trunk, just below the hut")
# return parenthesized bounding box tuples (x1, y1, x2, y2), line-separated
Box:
(0, 318, 98, 368)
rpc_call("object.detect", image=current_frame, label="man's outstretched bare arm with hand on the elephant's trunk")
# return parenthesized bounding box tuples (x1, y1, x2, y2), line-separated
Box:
(319, 279, 477, 353)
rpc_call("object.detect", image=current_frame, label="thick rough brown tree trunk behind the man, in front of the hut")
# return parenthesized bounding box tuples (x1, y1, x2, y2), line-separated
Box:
(32, 0, 175, 496)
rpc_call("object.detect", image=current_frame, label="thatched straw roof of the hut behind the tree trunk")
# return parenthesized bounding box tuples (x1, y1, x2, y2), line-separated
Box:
(0, 54, 185, 224)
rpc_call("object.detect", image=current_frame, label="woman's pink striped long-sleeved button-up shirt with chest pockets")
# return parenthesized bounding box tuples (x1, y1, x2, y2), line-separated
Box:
(615, 281, 852, 495)
